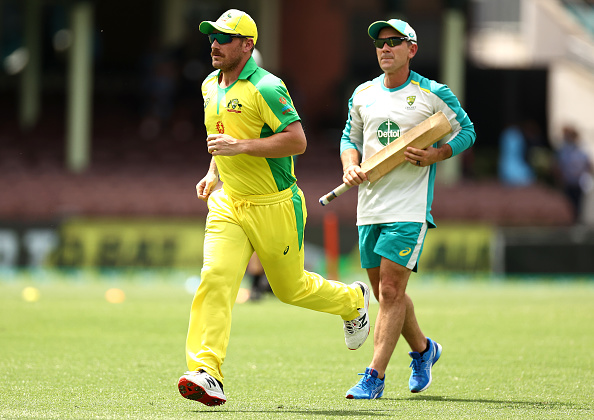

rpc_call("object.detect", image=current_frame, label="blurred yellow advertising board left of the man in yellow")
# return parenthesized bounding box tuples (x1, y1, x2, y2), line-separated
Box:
(48, 219, 204, 268)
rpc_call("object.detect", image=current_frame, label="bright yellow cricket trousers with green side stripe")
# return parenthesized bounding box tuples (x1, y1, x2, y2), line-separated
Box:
(186, 184, 364, 382)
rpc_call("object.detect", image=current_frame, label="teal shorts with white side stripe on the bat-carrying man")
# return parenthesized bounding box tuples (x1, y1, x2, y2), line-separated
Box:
(359, 222, 427, 272)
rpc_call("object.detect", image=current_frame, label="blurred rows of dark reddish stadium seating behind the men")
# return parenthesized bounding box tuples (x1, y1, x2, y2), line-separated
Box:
(0, 103, 571, 226)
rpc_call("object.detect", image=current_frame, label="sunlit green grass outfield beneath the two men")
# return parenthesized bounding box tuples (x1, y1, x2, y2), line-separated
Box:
(0, 272, 594, 419)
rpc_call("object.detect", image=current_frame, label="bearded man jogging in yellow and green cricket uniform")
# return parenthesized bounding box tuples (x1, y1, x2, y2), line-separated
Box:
(179, 9, 370, 405)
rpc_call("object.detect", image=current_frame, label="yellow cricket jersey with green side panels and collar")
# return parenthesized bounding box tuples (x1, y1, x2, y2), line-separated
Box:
(202, 58, 300, 195)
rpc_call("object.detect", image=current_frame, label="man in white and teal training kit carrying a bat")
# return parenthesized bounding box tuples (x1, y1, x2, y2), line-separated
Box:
(340, 19, 476, 399)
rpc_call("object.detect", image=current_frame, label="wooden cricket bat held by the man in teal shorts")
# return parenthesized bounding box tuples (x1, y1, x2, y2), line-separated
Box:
(320, 111, 452, 206)
